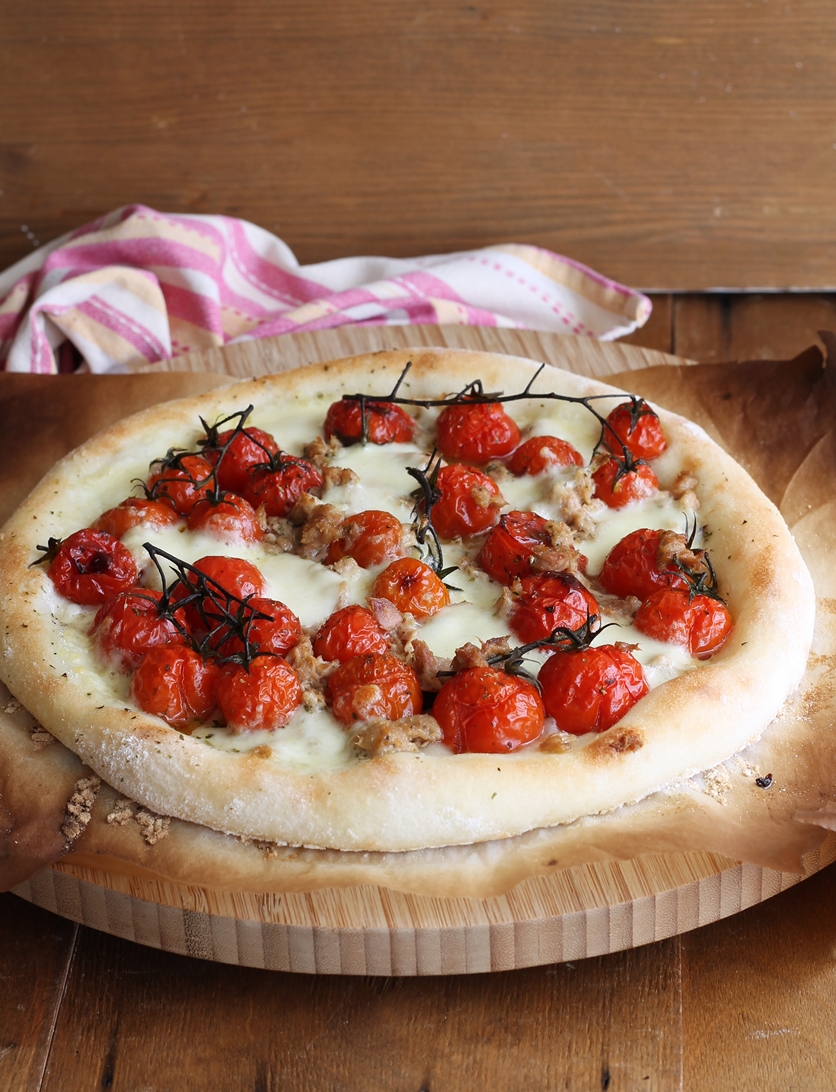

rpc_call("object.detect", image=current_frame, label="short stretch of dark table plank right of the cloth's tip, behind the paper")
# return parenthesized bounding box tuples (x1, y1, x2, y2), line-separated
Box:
(676, 293, 836, 364)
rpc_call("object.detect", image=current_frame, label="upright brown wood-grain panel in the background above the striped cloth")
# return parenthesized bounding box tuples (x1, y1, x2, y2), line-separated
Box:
(0, 0, 836, 289)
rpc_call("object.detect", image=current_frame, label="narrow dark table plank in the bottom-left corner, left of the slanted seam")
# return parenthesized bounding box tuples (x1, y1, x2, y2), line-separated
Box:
(0, 894, 79, 1092)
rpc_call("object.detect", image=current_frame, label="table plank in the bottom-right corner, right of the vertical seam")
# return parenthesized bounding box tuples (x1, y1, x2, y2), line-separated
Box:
(682, 867, 836, 1092)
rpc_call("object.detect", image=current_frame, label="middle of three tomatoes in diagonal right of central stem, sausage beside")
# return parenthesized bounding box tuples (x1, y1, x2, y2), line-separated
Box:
(479, 512, 586, 585)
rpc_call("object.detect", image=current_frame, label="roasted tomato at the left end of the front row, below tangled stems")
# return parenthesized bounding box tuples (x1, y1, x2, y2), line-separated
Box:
(131, 644, 218, 728)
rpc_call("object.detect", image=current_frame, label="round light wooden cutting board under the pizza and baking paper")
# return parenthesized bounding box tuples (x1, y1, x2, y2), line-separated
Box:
(9, 327, 836, 975)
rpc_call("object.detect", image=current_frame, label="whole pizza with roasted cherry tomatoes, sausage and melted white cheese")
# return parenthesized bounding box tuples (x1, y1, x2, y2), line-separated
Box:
(0, 349, 814, 853)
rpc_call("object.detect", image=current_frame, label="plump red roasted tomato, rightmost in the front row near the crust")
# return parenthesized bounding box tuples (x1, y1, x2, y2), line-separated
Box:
(537, 644, 649, 736)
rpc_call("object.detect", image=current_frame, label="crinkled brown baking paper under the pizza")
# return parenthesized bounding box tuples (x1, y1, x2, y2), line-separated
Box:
(0, 345, 836, 897)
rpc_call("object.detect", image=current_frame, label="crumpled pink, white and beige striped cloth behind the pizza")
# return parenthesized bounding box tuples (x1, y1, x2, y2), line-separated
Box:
(0, 205, 650, 373)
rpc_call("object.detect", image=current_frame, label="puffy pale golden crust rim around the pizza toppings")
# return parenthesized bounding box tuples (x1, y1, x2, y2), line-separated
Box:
(0, 349, 814, 852)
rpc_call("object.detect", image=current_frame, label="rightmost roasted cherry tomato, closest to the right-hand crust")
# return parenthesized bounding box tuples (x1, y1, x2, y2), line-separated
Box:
(633, 587, 732, 660)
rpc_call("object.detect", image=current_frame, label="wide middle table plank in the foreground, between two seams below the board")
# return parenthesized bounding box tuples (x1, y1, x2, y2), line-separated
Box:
(37, 930, 680, 1092)
